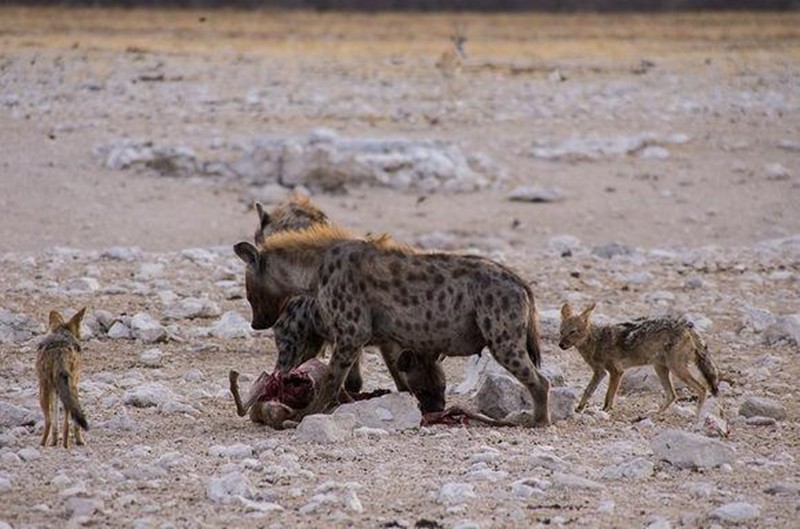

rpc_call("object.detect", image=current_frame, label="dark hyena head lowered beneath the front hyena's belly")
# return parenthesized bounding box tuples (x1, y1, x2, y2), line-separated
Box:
(397, 351, 447, 413)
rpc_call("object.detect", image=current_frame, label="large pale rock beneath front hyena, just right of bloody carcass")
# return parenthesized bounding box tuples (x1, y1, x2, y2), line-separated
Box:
(333, 393, 422, 432)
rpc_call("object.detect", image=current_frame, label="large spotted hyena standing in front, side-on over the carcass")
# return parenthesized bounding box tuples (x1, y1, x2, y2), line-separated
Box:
(234, 225, 550, 425)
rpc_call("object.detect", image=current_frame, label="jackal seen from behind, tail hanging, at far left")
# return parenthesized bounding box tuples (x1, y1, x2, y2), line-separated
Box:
(36, 308, 89, 448)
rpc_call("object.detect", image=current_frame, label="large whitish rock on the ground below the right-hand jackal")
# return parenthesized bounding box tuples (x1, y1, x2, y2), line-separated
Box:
(650, 430, 736, 468)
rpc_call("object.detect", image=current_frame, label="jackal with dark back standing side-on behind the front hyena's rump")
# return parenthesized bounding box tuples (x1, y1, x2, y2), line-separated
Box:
(558, 303, 719, 413)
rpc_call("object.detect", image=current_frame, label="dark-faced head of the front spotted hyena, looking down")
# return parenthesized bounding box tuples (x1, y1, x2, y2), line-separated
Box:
(233, 242, 286, 330)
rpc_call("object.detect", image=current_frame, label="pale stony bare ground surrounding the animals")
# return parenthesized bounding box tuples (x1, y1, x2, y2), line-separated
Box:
(0, 8, 800, 529)
